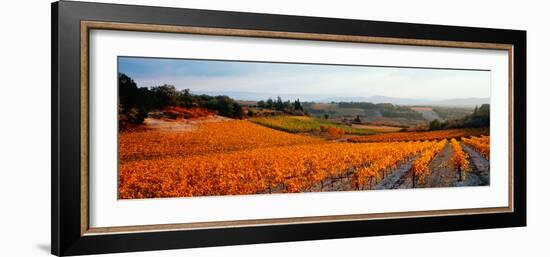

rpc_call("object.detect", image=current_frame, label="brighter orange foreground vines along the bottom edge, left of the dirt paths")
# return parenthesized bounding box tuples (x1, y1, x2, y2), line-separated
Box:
(119, 135, 440, 199)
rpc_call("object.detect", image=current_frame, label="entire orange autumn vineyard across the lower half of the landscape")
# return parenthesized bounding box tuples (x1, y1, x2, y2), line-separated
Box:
(118, 117, 489, 199)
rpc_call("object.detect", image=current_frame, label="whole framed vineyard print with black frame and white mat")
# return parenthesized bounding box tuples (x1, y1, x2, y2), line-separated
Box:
(52, 1, 526, 255)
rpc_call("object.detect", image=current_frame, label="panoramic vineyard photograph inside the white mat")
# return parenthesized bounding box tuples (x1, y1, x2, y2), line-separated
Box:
(118, 57, 491, 199)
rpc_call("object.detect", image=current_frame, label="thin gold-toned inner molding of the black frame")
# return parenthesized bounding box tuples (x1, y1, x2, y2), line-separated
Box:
(80, 21, 514, 236)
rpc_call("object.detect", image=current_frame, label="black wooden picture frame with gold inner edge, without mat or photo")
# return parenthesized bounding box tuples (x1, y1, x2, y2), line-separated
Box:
(51, 1, 526, 256)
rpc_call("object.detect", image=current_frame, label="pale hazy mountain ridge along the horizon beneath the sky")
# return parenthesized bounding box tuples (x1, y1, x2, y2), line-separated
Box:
(191, 91, 490, 107)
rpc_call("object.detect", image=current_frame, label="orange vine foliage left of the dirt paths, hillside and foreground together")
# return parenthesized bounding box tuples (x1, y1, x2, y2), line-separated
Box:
(118, 121, 444, 199)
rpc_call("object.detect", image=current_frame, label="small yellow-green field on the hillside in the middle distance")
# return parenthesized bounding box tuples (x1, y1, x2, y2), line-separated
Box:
(251, 116, 374, 135)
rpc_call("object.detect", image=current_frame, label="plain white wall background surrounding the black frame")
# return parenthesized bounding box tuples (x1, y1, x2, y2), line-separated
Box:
(0, 0, 550, 257)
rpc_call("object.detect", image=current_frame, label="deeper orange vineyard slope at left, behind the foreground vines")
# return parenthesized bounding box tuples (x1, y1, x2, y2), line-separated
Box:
(119, 120, 325, 162)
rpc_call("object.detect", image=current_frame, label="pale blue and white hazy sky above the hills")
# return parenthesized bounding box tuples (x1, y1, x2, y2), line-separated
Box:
(119, 57, 491, 99)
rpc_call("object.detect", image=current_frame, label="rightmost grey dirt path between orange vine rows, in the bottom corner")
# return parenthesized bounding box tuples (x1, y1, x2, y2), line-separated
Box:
(457, 143, 490, 186)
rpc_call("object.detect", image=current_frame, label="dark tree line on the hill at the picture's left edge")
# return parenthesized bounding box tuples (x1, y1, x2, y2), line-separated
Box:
(118, 73, 243, 124)
